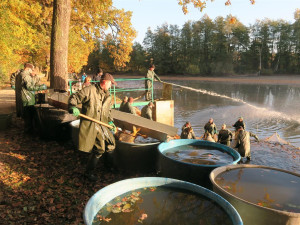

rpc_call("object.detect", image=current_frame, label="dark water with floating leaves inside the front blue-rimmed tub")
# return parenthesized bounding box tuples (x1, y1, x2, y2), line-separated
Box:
(93, 186, 232, 225)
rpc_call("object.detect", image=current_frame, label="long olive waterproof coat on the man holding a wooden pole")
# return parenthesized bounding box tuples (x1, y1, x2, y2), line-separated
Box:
(68, 84, 115, 152)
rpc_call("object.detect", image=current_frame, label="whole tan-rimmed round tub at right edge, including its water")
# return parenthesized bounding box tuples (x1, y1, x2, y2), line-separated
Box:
(210, 165, 300, 225)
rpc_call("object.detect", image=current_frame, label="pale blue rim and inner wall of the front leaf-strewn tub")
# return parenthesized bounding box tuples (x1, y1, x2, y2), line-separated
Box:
(83, 177, 243, 225)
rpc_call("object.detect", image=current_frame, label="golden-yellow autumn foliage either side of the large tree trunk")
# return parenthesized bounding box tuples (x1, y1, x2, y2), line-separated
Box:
(0, 0, 136, 83)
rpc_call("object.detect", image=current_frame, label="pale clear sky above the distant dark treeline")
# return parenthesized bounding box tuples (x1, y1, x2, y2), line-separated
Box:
(113, 0, 300, 44)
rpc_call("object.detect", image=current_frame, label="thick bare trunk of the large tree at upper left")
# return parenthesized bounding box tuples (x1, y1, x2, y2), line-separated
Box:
(50, 0, 71, 91)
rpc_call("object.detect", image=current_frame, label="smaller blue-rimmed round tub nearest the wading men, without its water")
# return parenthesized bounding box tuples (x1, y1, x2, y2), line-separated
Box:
(158, 139, 241, 188)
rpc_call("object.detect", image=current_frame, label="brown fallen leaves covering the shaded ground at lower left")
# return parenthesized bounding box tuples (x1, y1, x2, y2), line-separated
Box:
(0, 117, 154, 225)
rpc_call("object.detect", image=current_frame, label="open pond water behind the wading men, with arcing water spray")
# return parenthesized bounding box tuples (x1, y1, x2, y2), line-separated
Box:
(113, 77, 300, 172)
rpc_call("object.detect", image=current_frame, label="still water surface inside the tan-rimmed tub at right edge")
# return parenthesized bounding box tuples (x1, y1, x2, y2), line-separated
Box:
(215, 168, 300, 213)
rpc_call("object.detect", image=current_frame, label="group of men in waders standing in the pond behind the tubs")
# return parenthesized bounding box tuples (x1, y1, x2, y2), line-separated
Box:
(180, 117, 259, 161)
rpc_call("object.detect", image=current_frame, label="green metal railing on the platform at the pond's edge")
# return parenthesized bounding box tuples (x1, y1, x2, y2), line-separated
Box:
(69, 78, 154, 108)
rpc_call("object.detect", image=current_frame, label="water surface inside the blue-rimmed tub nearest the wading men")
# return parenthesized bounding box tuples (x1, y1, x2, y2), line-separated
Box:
(164, 145, 234, 166)
